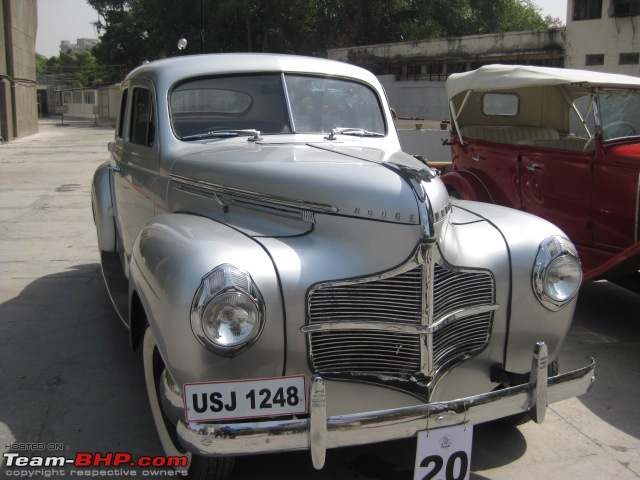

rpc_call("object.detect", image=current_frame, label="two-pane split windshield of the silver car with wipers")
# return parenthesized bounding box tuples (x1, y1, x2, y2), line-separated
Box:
(169, 74, 385, 140)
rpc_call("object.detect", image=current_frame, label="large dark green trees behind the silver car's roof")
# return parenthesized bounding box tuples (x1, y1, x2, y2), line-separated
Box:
(87, 0, 559, 68)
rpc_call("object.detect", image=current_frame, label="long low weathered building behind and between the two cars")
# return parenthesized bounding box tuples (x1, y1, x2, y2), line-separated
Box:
(328, 28, 565, 120)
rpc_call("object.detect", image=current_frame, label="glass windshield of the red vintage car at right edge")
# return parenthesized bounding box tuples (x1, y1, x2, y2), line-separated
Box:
(598, 90, 640, 141)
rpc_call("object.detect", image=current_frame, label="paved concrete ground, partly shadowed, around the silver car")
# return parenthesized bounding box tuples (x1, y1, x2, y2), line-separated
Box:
(0, 119, 640, 480)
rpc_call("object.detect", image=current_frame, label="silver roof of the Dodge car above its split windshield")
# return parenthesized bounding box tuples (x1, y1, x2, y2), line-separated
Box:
(127, 53, 377, 85)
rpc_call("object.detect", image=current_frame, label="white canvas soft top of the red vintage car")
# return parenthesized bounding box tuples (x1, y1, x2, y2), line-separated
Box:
(446, 65, 640, 99)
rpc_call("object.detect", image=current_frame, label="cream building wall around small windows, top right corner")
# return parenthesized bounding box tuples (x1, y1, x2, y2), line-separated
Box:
(564, 0, 640, 77)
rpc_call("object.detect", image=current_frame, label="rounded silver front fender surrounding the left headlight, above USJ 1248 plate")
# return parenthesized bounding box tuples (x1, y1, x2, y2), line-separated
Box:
(130, 214, 285, 386)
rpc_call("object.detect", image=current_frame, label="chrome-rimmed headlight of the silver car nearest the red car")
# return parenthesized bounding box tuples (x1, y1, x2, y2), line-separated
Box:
(532, 235, 582, 312)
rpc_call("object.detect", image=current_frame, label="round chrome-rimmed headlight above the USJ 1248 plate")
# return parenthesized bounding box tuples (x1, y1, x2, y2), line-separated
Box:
(191, 264, 265, 357)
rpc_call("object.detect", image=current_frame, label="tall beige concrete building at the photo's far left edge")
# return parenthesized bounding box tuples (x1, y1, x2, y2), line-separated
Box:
(0, 0, 38, 141)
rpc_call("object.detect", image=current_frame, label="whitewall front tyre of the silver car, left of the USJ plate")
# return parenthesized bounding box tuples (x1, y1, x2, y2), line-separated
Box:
(142, 326, 235, 480)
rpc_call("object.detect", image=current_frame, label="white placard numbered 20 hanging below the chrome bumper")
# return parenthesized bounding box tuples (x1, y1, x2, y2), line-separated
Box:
(413, 424, 473, 480)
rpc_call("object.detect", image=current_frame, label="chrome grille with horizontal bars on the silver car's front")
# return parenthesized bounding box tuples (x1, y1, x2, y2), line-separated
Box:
(308, 263, 495, 379)
